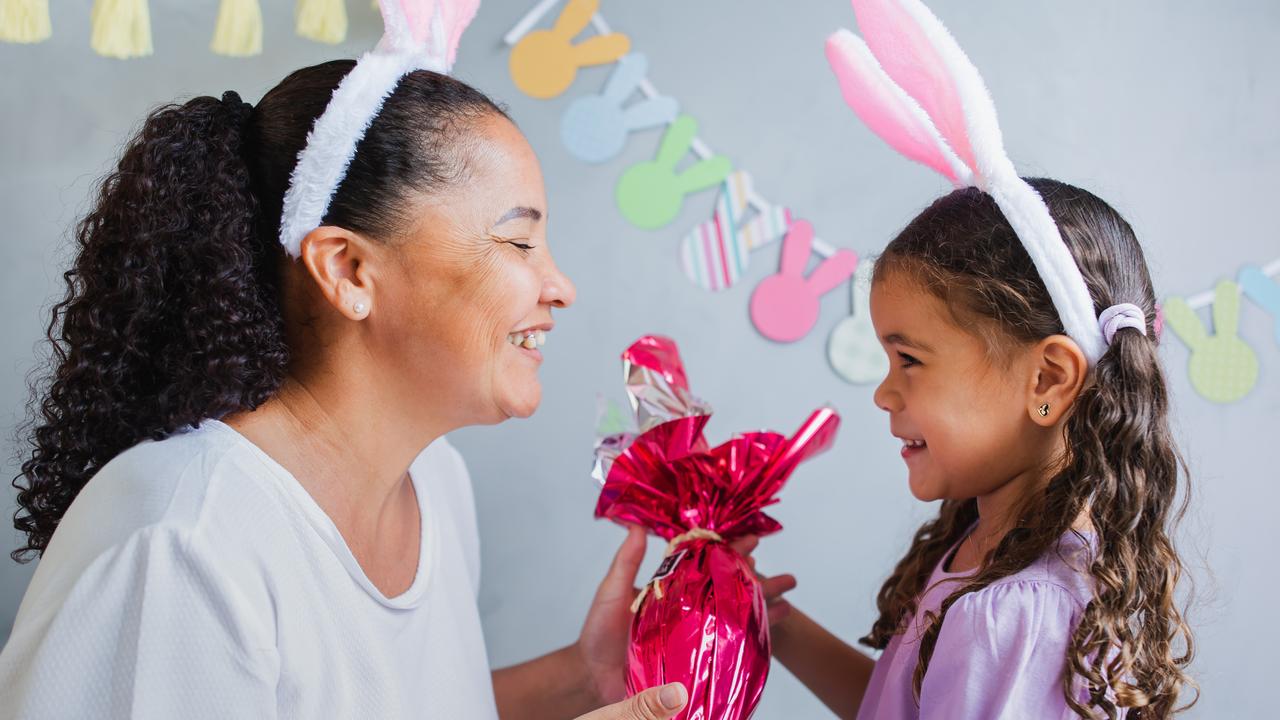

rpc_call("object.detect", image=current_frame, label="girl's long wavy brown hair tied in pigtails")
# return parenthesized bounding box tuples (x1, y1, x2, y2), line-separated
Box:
(860, 178, 1194, 717)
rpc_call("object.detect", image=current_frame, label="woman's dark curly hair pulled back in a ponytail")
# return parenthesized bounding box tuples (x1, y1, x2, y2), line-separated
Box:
(12, 60, 504, 562)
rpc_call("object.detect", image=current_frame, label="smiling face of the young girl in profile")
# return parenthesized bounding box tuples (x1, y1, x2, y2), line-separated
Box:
(870, 272, 1044, 501)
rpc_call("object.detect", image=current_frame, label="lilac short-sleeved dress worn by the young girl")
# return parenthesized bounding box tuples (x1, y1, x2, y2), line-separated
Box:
(858, 533, 1092, 720)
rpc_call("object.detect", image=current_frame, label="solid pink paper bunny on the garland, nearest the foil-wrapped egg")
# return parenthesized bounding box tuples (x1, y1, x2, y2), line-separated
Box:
(751, 220, 858, 342)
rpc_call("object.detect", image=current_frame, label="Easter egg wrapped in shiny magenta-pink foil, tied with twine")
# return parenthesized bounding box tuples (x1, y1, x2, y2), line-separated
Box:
(593, 336, 840, 720)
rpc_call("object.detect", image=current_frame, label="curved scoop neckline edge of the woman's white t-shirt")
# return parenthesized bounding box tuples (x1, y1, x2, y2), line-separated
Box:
(201, 419, 440, 610)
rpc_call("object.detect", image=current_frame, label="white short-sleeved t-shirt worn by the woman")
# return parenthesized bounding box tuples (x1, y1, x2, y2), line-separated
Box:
(0, 421, 498, 720)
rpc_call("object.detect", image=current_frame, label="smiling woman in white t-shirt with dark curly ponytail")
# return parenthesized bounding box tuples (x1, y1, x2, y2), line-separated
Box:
(0, 61, 790, 719)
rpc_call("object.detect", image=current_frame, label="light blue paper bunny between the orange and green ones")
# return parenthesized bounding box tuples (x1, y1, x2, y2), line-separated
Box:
(561, 53, 680, 163)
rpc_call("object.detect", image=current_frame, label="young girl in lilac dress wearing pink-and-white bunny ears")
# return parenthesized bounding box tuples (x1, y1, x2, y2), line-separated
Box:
(773, 0, 1192, 720)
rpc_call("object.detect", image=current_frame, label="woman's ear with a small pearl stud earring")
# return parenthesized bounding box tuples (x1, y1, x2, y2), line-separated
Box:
(298, 225, 374, 320)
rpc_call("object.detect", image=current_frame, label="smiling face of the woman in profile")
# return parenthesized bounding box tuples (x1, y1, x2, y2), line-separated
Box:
(369, 114, 575, 427)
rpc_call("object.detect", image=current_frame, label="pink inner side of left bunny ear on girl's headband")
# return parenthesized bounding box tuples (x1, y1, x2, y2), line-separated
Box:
(827, 29, 969, 186)
